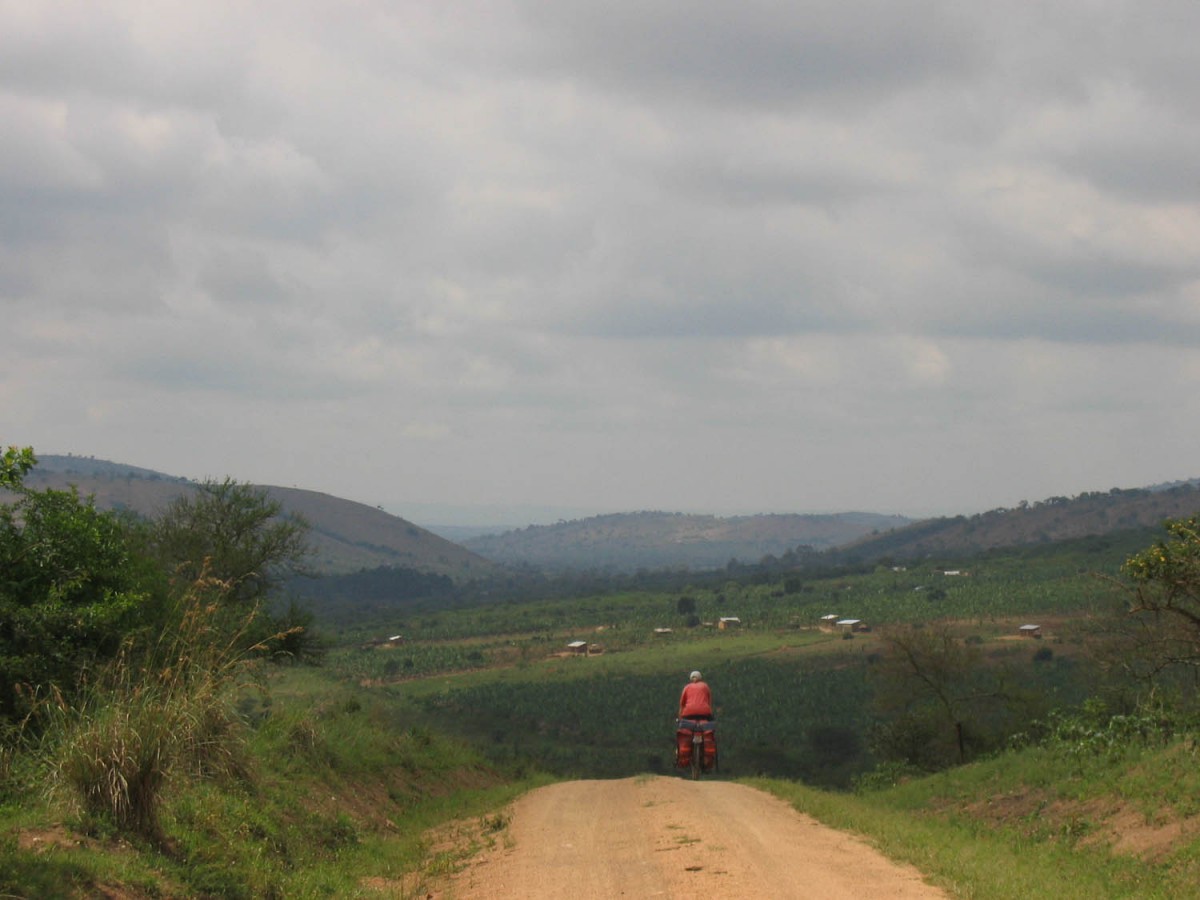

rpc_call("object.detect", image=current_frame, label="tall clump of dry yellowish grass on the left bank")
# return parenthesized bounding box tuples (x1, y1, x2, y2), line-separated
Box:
(44, 576, 274, 842)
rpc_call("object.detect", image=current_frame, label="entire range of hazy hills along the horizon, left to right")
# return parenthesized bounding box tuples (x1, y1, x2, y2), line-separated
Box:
(18, 456, 1200, 583)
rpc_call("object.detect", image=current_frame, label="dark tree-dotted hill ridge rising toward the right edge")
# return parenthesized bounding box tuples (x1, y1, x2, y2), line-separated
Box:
(836, 481, 1200, 559)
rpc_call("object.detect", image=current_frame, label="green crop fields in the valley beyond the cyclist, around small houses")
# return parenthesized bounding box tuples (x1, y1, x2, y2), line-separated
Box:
(329, 542, 1120, 788)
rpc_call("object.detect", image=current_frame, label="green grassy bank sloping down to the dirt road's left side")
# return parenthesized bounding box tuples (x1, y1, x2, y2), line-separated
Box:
(0, 668, 546, 898)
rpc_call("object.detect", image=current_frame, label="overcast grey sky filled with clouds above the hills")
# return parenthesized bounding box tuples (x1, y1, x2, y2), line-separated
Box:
(0, 0, 1200, 524)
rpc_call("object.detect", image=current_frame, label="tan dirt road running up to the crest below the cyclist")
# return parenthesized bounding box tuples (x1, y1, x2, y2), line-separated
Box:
(438, 776, 947, 900)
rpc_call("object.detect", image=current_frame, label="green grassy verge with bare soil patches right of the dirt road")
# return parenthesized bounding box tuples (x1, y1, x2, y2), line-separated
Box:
(748, 742, 1200, 900)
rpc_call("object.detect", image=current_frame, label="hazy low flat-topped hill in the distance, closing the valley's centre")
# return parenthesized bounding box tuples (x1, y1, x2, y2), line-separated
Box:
(463, 512, 913, 571)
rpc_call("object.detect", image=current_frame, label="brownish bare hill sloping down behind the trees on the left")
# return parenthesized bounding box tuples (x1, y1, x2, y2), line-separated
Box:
(18, 456, 496, 582)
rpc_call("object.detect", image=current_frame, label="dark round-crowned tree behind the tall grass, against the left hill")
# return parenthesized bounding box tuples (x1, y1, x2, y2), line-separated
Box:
(155, 479, 311, 606)
